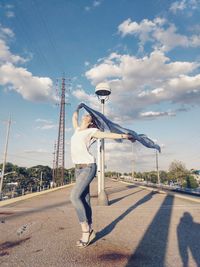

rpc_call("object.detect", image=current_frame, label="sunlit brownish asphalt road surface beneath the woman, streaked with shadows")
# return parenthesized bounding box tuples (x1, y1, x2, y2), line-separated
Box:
(0, 180, 200, 267)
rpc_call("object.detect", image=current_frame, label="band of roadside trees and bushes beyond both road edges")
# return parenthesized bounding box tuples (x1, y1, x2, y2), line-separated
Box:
(0, 161, 200, 200)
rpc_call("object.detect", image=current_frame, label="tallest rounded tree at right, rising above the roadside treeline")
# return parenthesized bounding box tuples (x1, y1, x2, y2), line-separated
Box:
(169, 160, 189, 186)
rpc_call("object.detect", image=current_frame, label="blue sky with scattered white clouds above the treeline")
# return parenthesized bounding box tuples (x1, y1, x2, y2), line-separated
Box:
(0, 0, 200, 172)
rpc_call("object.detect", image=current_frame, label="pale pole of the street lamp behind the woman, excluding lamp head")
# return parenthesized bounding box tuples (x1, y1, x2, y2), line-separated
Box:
(98, 99, 108, 206)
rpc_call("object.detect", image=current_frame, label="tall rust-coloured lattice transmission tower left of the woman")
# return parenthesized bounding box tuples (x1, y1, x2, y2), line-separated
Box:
(55, 78, 65, 185)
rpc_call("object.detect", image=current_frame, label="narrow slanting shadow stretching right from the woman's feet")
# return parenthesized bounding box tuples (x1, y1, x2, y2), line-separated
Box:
(94, 192, 155, 242)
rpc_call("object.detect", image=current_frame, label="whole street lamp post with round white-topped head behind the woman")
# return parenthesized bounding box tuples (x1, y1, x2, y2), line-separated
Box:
(95, 83, 111, 206)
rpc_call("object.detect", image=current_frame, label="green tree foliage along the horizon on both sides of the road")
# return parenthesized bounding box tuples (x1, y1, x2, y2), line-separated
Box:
(0, 161, 198, 191)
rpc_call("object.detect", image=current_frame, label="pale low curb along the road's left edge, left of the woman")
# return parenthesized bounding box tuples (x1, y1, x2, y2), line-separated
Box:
(0, 183, 74, 207)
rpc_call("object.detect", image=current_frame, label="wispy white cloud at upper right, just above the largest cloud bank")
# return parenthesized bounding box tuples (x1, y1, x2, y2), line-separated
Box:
(118, 17, 200, 51)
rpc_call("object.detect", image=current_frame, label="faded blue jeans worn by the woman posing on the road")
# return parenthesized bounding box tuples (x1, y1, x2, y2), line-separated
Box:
(70, 163, 97, 224)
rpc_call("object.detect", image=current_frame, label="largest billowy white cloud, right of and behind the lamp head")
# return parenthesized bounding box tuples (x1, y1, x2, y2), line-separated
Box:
(83, 50, 200, 123)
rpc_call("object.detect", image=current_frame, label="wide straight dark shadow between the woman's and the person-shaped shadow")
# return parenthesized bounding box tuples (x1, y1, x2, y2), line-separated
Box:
(126, 196, 174, 267)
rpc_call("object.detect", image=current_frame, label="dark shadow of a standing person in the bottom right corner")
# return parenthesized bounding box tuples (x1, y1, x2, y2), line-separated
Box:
(177, 212, 200, 267)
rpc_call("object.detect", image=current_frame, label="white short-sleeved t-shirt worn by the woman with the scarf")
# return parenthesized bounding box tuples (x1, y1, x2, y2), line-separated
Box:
(71, 128, 98, 164)
